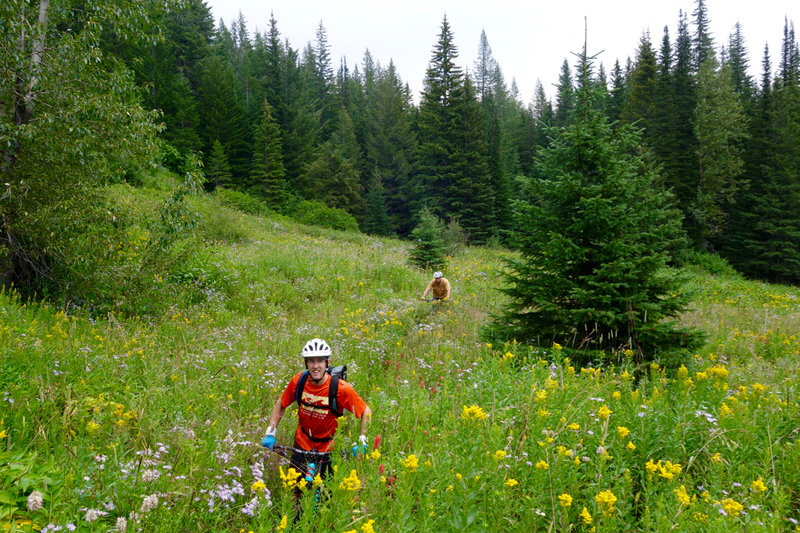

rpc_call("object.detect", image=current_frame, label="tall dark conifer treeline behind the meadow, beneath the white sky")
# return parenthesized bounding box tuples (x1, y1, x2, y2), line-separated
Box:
(3, 0, 800, 296)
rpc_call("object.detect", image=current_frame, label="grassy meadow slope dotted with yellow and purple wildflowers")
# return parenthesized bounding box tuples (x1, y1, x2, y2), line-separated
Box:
(0, 185, 800, 532)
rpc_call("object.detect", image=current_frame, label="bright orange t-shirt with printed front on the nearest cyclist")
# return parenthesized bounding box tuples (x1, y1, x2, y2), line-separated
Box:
(281, 372, 367, 452)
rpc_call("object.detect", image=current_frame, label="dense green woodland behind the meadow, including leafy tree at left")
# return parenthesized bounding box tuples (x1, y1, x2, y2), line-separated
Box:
(0, 0, 800, 291)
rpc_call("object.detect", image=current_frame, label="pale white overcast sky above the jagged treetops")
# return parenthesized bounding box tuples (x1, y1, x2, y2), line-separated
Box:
(206, 0, 800, 103)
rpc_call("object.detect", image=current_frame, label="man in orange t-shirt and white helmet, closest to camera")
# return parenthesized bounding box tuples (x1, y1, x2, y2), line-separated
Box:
(261, 339, 372, 490)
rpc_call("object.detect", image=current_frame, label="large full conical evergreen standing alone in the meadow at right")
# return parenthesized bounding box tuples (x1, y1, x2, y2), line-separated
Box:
(492, 48, 697, 360)
